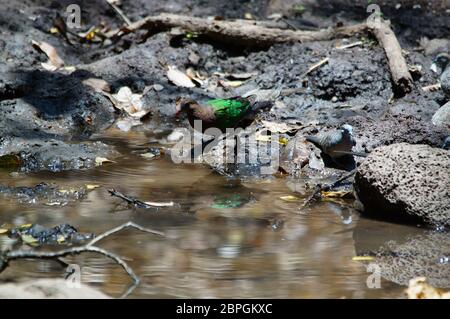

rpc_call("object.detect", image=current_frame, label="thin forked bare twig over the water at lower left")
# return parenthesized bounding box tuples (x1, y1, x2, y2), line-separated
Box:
(0, 222, 164, 298)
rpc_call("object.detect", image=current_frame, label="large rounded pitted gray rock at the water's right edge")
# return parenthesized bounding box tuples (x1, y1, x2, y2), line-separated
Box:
(354, 143, 450, 225)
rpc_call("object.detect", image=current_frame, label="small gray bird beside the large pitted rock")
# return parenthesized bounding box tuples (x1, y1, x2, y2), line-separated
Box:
(306, 124, 356, 159)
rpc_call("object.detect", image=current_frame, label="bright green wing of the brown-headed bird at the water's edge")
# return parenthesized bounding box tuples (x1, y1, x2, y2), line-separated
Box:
(206, 97, 251, 128)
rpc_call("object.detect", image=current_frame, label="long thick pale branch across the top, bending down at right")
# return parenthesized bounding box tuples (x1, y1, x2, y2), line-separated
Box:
(105, 13, 413, 95)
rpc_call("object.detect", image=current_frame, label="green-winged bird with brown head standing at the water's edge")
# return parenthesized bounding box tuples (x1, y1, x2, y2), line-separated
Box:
(176, 95, 273, 133)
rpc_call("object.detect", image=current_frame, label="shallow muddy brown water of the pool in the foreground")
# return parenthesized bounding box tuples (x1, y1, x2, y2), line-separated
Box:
(0, 128, 442, 298)
